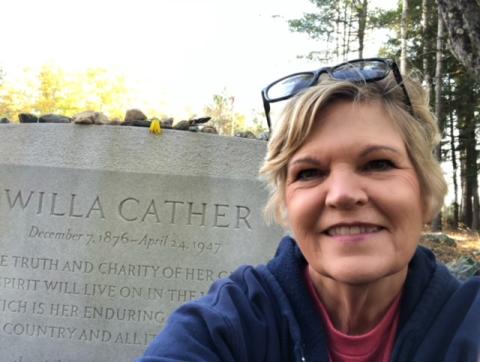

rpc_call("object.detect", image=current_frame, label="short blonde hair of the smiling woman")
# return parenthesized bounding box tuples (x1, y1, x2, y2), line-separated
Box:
(260, 77, 447, 226)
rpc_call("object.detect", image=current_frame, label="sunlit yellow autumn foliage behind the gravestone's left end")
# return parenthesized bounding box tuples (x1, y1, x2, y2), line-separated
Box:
(0, 64, 129, 120)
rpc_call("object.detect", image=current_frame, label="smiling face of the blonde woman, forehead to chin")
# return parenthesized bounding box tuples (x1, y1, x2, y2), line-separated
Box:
(285, 101, 425, 284)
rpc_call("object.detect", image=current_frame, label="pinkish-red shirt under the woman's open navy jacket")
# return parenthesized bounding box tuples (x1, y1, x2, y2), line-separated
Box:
(305, 267, 401, 362)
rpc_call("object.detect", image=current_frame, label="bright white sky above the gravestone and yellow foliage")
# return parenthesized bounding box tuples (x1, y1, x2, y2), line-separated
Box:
(0, 0, 395, 117)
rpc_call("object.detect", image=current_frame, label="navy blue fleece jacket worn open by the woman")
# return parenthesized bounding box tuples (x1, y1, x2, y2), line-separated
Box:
(137, 237, 480, 362)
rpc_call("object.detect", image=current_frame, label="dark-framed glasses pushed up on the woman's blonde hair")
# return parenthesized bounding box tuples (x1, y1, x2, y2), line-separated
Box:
(262, 58, 413, 130)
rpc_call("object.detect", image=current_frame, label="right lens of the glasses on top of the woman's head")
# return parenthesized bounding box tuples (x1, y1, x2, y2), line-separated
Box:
(331, 60, 390, 82)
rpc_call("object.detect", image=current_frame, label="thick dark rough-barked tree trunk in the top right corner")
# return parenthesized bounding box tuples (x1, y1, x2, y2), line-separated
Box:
(437, 0, 480, 80)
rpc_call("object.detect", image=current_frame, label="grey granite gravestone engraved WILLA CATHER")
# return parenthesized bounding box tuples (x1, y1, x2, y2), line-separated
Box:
(0, 124, 281, 362)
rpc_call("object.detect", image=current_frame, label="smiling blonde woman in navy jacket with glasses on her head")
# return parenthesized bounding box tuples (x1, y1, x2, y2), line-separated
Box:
(136, 59, 480, 361)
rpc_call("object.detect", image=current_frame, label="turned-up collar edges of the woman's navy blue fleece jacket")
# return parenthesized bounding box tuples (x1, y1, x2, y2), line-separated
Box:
(267, 236, 459, 361)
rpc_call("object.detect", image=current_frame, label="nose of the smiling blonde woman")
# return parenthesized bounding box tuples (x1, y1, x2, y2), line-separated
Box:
(325, 170, 368, 209)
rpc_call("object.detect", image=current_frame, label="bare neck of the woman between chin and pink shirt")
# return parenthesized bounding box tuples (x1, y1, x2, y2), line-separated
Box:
(309, 267, 408, 335)
